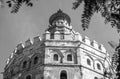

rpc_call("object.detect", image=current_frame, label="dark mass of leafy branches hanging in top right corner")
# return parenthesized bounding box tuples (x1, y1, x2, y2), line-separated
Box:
(73, 0, 120, 32)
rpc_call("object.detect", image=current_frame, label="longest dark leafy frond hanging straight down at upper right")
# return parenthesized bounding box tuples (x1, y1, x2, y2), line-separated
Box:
(81, 0, 96, 30)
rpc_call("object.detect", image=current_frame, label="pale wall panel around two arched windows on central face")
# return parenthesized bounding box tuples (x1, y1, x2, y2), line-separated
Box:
(45, 47, 74, 65)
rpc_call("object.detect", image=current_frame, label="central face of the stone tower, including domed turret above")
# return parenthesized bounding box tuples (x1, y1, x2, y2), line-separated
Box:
(44, 10, 81, 79)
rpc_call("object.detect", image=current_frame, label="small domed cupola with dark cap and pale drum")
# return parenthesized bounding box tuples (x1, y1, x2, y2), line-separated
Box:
(48, 9, 71, 34)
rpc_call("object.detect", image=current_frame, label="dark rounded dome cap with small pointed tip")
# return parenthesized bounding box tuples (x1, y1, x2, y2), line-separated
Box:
(49, 9, 71, 25)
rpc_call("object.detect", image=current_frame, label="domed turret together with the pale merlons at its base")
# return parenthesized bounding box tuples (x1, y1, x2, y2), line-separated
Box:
(44, 9, 73, 40)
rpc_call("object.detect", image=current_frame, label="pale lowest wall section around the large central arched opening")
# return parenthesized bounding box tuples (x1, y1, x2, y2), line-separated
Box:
(44, 66, 81, 79)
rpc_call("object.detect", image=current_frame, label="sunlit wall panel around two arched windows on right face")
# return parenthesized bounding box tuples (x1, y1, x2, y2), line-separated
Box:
(79, 49, 104, 74)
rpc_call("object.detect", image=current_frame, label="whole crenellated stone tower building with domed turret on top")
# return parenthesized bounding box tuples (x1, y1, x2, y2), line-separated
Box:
(3, 10, 114, 79)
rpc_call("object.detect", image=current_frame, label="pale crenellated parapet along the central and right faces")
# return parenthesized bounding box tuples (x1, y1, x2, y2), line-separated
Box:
(45, 30, 106, 53)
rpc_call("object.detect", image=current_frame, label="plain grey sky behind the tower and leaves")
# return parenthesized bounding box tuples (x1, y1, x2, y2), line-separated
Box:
(0, 0, 119, 79)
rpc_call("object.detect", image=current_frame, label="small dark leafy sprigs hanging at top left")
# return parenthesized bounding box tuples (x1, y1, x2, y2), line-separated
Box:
(6, 0, 33, 13)
